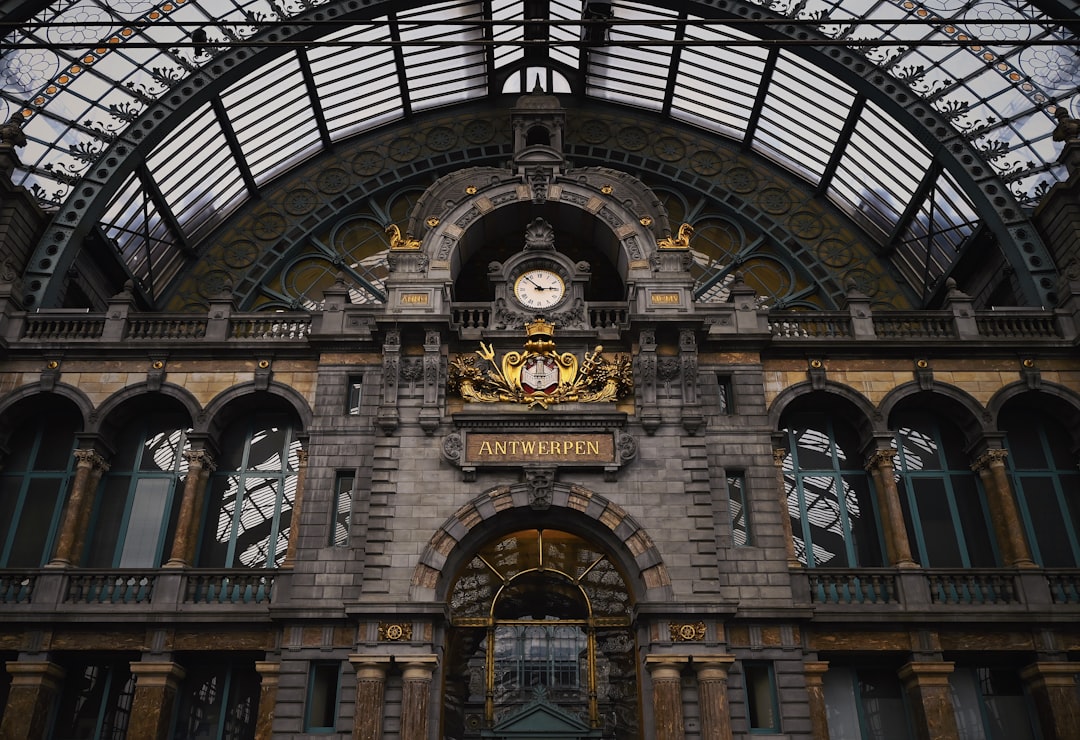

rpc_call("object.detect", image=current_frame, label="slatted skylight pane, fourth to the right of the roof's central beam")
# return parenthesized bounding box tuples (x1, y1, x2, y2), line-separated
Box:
(829, 103, 931, 236)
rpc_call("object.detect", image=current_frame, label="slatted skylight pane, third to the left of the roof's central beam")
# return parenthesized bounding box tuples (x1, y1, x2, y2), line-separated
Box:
(221, 52, 322, 185)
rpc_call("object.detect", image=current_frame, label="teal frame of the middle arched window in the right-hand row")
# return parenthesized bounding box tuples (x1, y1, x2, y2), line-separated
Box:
(893, 413, 1001, 568)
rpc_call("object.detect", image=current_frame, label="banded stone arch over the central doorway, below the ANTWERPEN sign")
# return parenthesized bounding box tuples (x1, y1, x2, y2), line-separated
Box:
(409, 483, 673, 602)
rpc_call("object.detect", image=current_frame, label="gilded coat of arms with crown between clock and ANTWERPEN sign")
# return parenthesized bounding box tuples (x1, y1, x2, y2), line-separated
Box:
(449, 319, 634, 408)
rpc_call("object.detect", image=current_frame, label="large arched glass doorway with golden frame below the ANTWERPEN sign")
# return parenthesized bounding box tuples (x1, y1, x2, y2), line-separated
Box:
(443, 528, 639, 740)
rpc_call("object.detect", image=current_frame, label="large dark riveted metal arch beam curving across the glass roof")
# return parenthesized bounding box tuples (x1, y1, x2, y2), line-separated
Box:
(16, 0, 1056, 306)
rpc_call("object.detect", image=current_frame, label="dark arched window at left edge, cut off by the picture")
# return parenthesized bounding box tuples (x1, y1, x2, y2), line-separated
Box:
(0, 400, 81, 568)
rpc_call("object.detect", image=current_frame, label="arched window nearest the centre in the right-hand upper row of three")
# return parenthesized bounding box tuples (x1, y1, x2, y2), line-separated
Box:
(783, 413, 882, 567)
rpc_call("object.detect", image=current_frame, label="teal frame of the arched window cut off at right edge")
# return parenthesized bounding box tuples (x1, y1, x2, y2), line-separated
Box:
(1004, 414, 1080, 567)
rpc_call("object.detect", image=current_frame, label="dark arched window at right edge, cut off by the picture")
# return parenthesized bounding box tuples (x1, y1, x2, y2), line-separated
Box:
(999, 406, 1080, 568)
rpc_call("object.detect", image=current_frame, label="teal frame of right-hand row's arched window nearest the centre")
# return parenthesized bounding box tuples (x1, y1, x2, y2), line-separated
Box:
(781, 413, 885, 568)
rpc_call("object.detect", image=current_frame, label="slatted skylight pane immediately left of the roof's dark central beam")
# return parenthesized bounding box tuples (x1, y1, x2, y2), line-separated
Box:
(399, 2, 487, 110)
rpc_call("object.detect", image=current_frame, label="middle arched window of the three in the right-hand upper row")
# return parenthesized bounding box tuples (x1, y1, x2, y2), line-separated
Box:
(893, 412, 998, 568)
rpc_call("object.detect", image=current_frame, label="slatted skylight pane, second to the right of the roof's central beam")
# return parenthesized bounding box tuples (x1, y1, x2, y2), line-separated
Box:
(672, 19, 768, 139)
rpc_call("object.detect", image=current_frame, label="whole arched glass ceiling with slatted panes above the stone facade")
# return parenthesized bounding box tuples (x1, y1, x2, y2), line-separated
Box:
(0, 0, 1080, 305)
